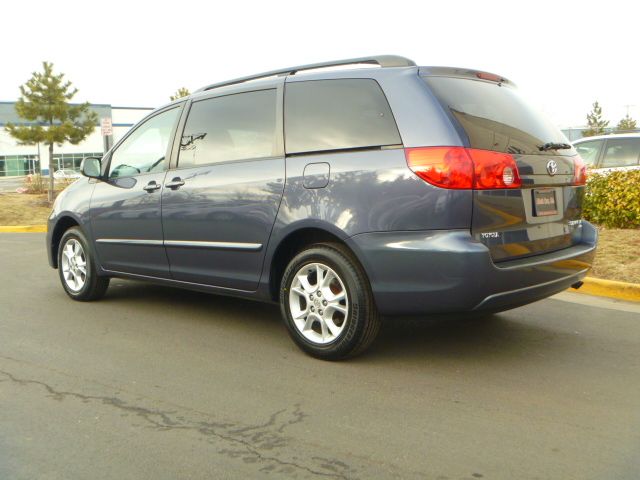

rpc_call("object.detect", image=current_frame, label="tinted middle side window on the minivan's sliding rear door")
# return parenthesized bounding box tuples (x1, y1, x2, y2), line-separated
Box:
(178, 90, 277, 167)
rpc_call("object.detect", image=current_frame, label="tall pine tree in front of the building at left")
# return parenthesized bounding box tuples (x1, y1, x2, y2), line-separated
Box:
(6, 62, 98, 202)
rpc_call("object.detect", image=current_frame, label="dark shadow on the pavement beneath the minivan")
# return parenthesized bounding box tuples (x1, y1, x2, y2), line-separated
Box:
(99, 280, 579, 363)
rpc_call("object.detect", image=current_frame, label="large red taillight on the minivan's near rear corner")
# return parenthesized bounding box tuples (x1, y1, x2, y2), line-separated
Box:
(405, 147, 522, 190)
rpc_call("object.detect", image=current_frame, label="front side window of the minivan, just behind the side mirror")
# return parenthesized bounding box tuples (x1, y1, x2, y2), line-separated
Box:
(109, 107, 180, 178)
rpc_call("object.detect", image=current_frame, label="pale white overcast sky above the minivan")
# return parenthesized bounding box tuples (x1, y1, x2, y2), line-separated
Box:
(0, 0, 640, 126)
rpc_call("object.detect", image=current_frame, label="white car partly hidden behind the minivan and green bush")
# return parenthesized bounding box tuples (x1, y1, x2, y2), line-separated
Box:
(573, 133, 640, 173)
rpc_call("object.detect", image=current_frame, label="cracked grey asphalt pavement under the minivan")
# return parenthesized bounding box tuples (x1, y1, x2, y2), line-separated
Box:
(0, 234, 640, 480)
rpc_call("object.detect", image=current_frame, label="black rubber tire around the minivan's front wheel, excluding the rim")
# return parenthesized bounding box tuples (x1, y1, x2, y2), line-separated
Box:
(58, 227, 109, 302)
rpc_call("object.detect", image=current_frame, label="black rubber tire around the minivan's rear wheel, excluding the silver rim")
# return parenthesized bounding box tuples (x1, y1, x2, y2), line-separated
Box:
(280, 243, 380, 360)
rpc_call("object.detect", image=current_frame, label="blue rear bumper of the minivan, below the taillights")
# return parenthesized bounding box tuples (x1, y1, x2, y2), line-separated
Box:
(349, 221, 597, 315)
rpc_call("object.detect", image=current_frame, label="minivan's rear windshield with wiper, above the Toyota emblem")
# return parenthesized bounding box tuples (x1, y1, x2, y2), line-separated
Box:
(422, 76, 575, 155)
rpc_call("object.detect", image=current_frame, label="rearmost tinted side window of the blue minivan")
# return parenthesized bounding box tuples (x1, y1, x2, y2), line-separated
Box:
(284, 79, 402, 153)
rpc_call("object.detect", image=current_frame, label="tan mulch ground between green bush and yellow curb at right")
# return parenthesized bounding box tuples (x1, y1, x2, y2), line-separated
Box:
(589, 228, 640, 283)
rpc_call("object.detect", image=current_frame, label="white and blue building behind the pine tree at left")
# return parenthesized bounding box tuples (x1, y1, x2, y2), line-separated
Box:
(0, 102, 153, 176)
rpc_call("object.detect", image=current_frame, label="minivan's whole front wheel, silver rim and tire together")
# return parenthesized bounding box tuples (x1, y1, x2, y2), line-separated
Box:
(58, 227, 109, 301)
